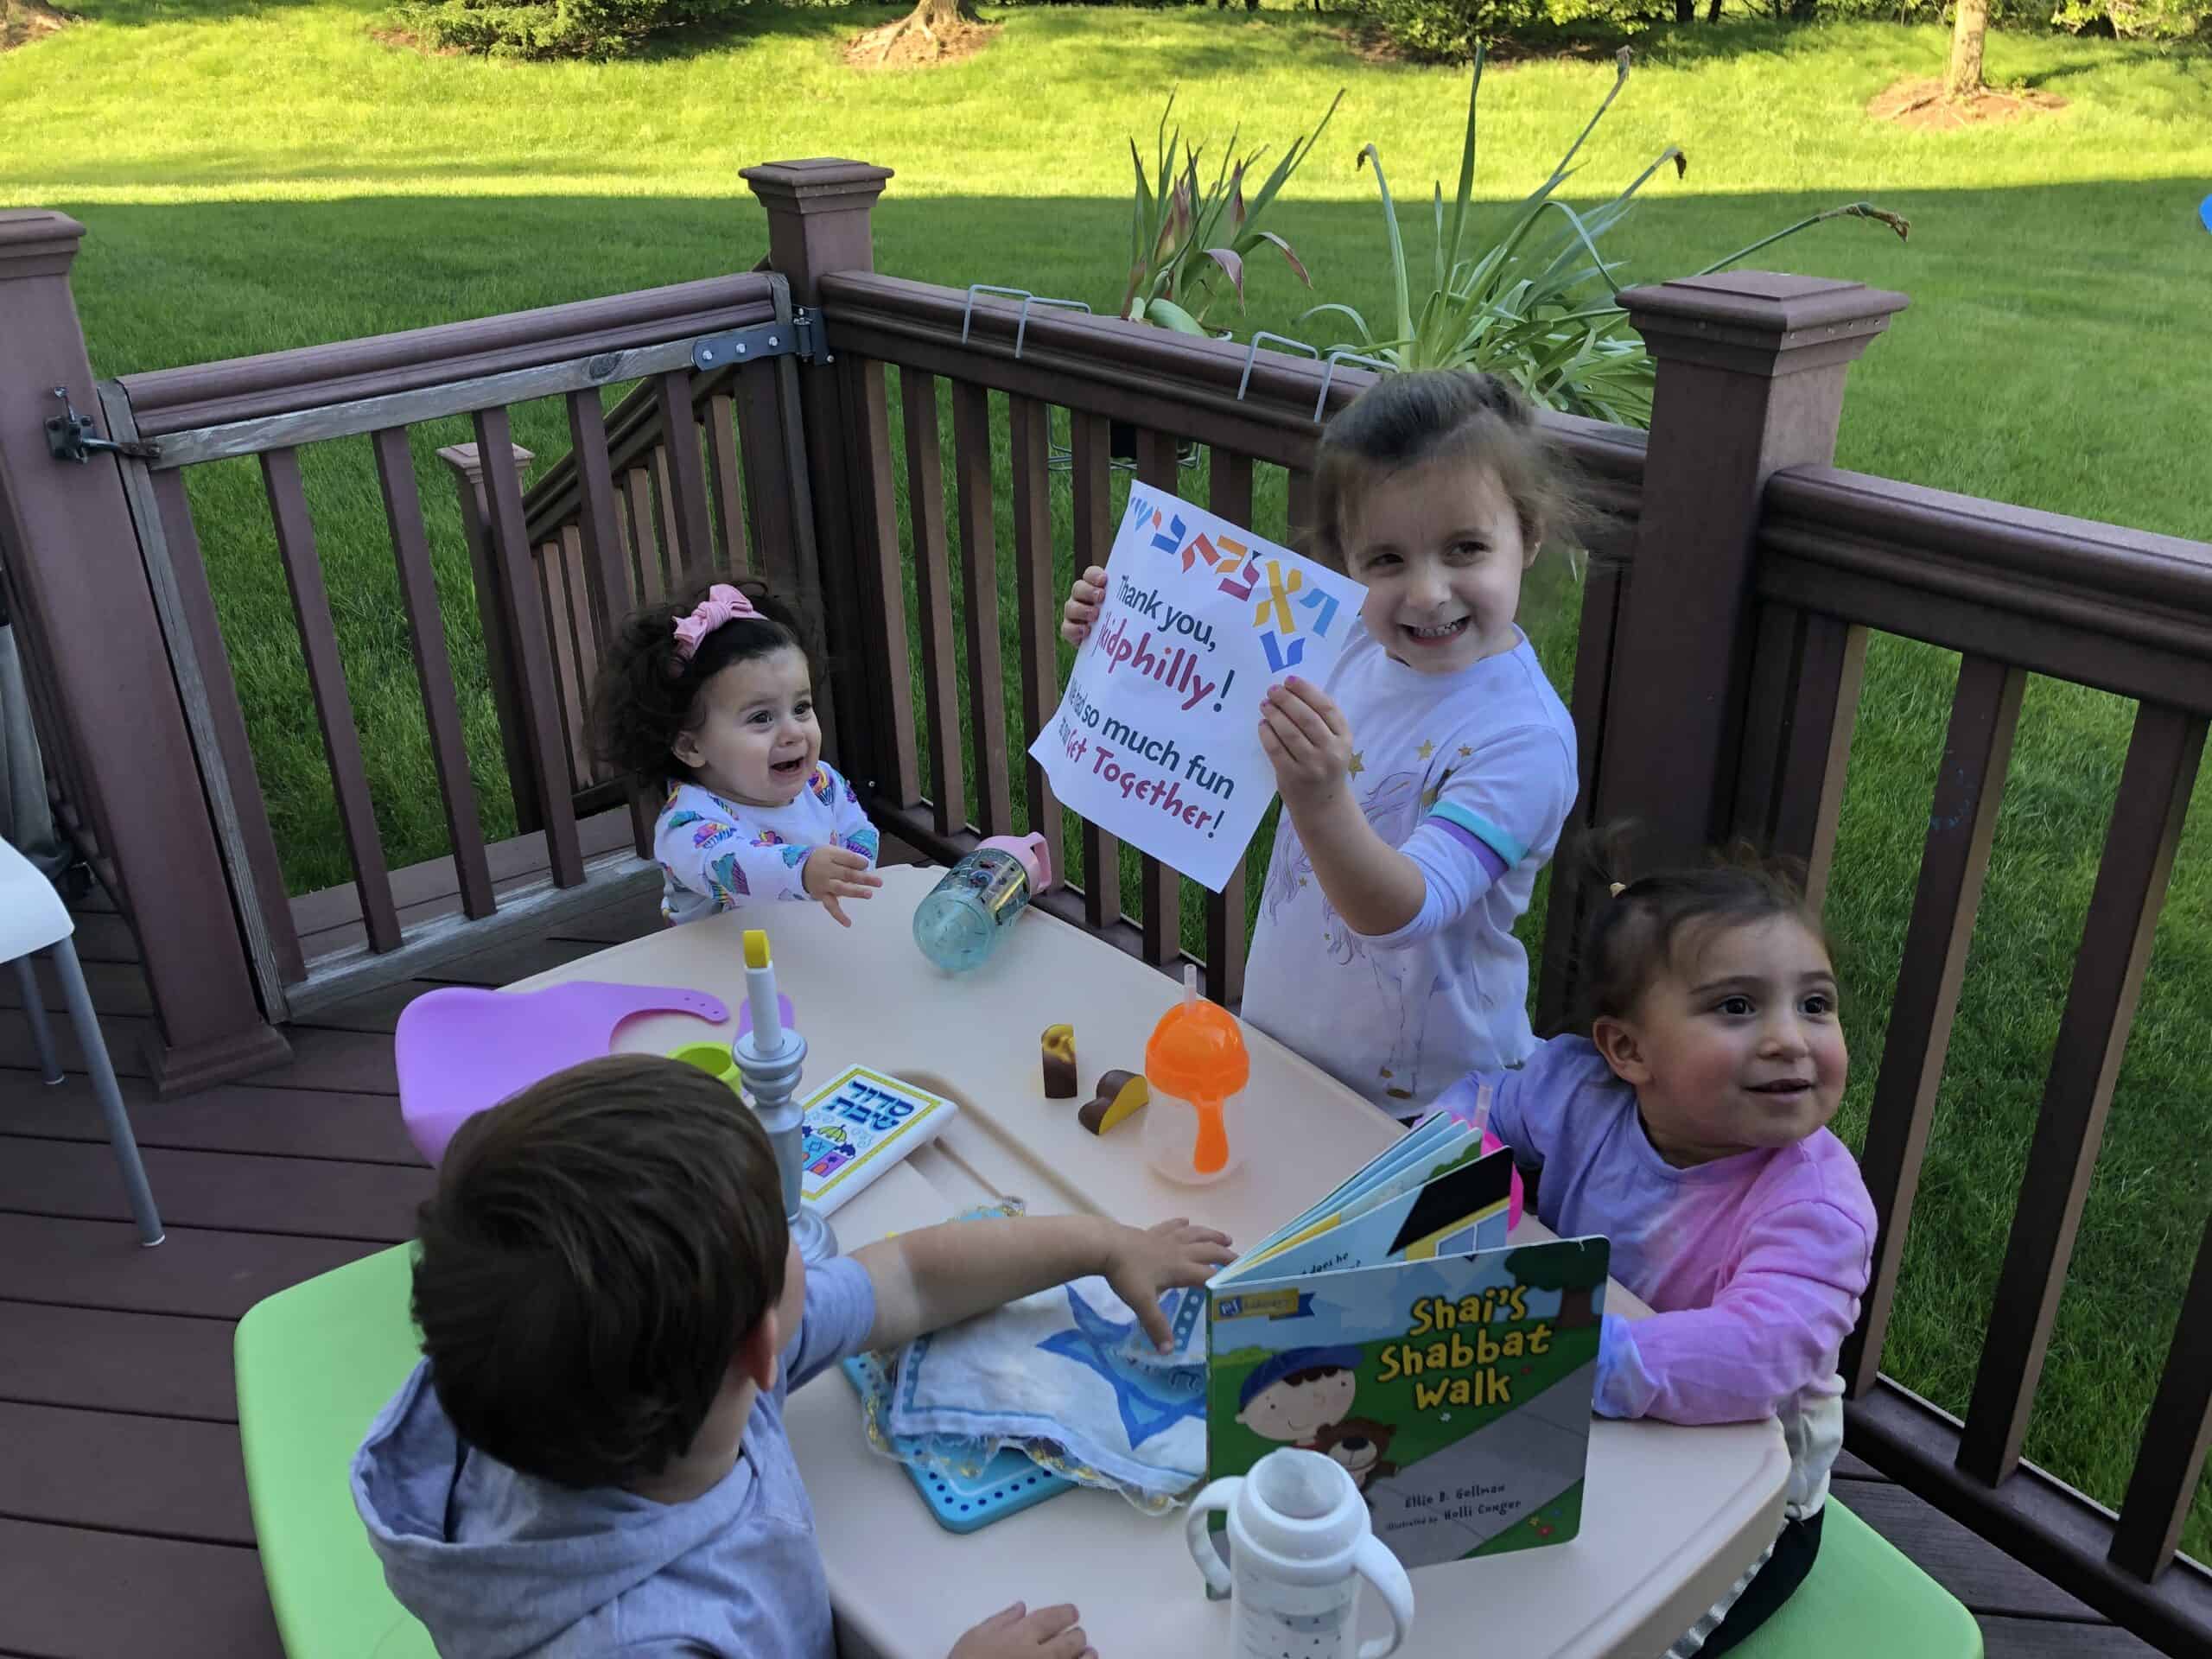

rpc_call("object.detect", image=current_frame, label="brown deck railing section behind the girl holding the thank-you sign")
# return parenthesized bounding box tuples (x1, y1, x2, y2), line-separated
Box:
(818, 272, 1643, 1002)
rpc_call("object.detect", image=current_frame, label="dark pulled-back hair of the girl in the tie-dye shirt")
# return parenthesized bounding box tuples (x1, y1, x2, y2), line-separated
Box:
(1561, 825, 1827, 1035)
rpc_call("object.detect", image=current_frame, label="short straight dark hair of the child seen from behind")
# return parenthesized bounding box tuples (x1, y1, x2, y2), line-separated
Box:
(414, 1055, 787, 1486)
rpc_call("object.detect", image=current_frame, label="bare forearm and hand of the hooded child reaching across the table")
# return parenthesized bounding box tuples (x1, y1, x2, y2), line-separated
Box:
(852, 1214, 1232, 1350)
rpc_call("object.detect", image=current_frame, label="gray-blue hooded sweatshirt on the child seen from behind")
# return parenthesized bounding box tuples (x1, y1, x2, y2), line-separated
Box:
(354, 1259, 876, 1659)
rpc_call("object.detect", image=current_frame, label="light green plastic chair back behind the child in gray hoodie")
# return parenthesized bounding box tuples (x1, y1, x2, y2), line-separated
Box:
(234, 1245, 438, 1659)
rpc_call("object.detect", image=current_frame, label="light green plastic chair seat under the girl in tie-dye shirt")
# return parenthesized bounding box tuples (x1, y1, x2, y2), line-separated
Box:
(1732, 1493, 1982, 1659)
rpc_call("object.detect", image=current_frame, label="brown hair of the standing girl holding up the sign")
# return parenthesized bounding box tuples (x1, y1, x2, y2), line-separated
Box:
(1292, 370, 1595, 570)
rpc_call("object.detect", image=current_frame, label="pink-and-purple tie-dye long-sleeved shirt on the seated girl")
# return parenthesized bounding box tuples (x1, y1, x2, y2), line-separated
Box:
(1438, 1038, 1873, 1516)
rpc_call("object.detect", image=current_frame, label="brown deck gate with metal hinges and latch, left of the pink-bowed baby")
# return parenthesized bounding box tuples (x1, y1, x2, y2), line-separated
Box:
(10, 261, 823, 1018)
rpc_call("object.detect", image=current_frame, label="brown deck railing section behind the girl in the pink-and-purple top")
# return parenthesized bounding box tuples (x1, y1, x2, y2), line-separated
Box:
(1757, 469, 2212, 1652)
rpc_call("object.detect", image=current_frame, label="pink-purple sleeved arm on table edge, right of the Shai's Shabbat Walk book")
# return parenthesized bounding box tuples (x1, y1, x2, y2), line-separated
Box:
(1595, 1199, 1873, 1422)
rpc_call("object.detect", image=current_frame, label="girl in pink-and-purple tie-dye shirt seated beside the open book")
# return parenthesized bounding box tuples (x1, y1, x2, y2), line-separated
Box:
(1438, 849, 1873, 1659)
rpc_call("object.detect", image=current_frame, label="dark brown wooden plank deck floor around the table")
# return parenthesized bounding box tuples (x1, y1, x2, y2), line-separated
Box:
(0, 893, 2152, 1659)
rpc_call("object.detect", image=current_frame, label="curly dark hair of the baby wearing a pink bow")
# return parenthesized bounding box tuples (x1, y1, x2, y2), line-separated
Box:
(591, 577, 818, 785)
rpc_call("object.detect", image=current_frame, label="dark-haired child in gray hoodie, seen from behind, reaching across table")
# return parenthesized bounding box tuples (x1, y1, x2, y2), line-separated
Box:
(354, 1055, 1230, 1659)
